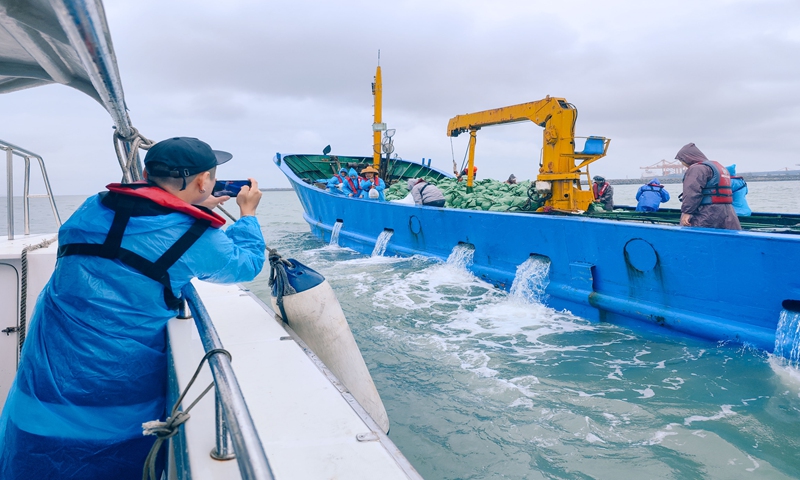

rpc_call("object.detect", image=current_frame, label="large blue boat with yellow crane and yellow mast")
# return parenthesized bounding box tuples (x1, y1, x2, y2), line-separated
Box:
(274, 67, 800, 351)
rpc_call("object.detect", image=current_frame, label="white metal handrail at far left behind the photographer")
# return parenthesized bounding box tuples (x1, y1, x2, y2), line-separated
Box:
(0, 140, 61, 240)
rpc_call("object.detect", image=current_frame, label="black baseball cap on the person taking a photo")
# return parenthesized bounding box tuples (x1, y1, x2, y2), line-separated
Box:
(144, 137, 233, 179)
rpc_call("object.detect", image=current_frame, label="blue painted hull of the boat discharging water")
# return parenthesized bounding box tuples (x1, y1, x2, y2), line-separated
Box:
(276, 159, 800, 352)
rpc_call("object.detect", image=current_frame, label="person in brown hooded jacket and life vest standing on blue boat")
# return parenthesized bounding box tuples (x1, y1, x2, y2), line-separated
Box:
(675, 143, 742, 230)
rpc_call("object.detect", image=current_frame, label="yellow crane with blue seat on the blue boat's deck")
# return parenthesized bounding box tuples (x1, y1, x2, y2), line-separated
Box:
(447, 96, 611, 211)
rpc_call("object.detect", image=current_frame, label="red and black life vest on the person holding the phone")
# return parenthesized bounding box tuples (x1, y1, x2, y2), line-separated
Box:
(58, 182, 225, 310)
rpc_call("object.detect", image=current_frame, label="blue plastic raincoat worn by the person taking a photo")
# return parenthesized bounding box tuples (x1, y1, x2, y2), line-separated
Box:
(0, 191, 265, 480)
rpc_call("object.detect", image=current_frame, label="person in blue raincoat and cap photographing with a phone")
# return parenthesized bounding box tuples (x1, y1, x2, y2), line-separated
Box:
(0, 137, 265, 480)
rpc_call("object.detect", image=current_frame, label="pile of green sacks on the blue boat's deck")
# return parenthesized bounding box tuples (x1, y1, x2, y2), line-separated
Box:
(384, 178, 531, 212)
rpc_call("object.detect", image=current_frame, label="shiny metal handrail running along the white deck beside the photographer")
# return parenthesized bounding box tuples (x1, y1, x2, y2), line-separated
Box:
(183, 283, 275, 480)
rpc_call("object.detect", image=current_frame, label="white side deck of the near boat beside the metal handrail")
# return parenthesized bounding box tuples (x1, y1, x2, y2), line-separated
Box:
(168, 281, 420, 480)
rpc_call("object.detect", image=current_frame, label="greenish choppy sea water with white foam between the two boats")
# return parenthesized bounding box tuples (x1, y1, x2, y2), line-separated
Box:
(6, 188, 800, 480)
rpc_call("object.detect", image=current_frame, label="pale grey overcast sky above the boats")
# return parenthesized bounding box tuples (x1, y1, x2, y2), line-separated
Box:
(0, 0, 800, 194)
